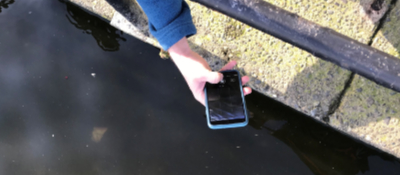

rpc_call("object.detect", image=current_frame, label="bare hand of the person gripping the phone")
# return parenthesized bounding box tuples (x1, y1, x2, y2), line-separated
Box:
(168, 37, 251, 105)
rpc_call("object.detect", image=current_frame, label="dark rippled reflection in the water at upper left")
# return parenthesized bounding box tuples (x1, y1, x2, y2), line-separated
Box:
(66, 3, 126, 51)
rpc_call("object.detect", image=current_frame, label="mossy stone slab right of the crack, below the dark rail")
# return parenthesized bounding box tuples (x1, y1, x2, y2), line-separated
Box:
(330, 75, 400, 157)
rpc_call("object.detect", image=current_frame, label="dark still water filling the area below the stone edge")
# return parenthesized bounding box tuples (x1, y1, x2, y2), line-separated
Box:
(0, 0, 400, 175)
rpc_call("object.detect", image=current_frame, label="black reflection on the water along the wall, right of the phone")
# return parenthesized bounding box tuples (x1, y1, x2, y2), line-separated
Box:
(246, 92, 400, 174)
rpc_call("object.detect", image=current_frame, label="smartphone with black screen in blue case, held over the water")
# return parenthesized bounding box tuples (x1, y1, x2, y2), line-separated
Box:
(204, 70, 249, 129)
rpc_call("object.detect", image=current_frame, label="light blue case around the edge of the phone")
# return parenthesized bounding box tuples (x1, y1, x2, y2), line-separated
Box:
(204, 70, 249, 129)
